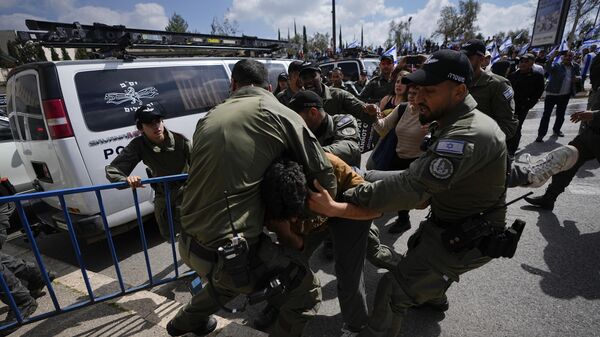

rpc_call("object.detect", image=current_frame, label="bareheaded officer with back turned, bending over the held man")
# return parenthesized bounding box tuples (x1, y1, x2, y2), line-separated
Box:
(167, 59, 336, 336)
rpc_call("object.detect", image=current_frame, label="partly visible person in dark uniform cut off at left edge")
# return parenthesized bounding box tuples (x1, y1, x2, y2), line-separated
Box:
(0, 178, 56, 326)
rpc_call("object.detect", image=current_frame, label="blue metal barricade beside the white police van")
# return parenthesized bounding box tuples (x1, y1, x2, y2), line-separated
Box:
(0, 174, 194, 333)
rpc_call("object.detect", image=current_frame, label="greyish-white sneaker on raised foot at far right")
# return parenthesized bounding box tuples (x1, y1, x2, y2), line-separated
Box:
(517, 145, 579, 187)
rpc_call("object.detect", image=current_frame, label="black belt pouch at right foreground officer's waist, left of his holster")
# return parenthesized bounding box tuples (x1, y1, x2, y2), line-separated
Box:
(442, 216, 492, 253)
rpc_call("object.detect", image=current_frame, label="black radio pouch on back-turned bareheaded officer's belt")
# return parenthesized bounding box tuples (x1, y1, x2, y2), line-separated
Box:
(217, 235, 250, 288)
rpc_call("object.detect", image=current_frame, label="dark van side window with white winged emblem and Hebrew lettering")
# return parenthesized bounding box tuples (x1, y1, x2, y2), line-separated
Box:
(75, 65, 229, 132)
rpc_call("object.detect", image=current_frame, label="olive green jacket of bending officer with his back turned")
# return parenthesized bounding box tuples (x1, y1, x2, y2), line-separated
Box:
(181, 86, 336, 248)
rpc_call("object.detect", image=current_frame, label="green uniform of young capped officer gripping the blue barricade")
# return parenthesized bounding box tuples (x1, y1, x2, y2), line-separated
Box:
(105, 128, 191, 241)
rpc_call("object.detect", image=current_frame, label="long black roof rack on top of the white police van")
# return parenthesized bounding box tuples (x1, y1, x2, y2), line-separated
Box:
(17, 20, 288, 59)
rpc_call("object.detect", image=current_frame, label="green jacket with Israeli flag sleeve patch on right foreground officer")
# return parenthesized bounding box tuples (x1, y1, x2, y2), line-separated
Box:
(345, 95, 506, 226)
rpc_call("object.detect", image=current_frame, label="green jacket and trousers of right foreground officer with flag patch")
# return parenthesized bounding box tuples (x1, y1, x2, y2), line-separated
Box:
(346, 95, 506, 337)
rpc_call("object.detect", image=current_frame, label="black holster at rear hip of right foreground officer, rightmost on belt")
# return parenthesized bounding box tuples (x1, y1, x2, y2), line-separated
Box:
(479, 219, 525, 259)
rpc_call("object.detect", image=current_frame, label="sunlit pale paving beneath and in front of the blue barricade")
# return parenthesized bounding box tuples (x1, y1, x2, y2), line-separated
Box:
(0, 243, 267, 337)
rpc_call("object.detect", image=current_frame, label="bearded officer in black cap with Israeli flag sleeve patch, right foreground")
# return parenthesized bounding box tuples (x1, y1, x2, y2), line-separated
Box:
(309, 50, 506, 337)
